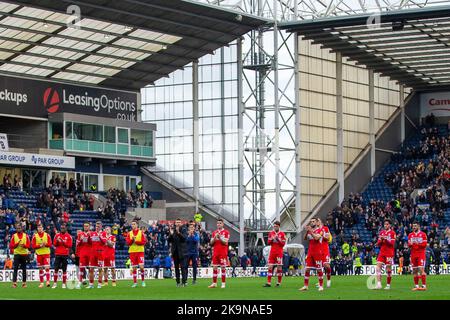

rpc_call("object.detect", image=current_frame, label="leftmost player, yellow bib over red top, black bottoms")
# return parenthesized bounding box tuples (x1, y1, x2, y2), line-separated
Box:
(9, 223, 30, 288)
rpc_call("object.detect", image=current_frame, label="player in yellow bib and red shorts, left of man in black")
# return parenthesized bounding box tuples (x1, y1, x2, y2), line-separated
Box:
(126, 221, 147, 288)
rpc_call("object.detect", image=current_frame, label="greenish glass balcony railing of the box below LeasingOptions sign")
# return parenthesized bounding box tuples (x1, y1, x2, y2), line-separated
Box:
(49, 139, 154, 158)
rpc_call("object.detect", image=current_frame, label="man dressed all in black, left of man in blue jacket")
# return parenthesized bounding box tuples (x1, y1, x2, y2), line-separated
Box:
(168, 219, 187, 287)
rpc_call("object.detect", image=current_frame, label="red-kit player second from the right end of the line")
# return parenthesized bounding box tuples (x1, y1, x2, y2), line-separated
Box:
(375, 219, 396, 290)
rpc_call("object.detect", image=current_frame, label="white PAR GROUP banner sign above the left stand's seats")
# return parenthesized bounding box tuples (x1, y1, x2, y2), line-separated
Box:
(0, 152, 75, 169)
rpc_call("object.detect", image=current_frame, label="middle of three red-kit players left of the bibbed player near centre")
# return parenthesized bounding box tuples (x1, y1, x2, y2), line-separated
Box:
(88, 221, 106, 289)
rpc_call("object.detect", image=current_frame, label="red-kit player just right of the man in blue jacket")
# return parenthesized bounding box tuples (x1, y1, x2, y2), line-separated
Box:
(208, 219, 230, 289)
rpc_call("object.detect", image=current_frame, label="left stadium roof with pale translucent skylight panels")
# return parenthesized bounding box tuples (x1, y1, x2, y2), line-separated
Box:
(0, 0, 267, 91)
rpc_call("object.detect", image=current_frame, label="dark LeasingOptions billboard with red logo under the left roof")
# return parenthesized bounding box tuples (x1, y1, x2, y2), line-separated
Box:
(0, 76, 138, 121)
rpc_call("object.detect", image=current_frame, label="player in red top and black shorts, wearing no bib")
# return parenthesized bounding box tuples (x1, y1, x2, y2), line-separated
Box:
(52, 223, 73, 289)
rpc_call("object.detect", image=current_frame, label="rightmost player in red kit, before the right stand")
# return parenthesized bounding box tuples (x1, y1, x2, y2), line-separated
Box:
(408, 221, 427, 291)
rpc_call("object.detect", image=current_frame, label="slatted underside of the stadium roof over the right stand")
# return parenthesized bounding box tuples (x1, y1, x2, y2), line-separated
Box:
(280, 6, 450, 89)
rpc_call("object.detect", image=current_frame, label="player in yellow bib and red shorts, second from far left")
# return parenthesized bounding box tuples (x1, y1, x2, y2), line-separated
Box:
(31, 224, 52, 288)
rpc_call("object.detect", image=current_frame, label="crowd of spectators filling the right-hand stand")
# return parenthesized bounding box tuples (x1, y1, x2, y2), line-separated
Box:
(326, 125, 450, 274)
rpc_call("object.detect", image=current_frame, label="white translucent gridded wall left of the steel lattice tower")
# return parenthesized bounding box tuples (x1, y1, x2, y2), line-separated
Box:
(142, 43, 239, 221)
